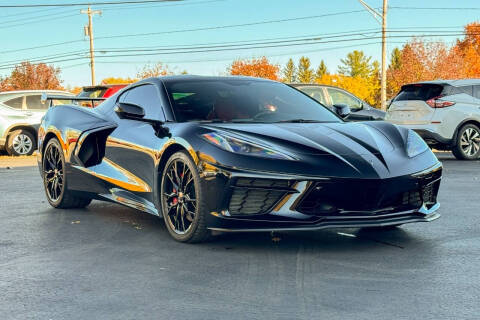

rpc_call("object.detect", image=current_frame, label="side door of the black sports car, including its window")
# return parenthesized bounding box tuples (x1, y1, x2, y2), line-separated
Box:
(95, 84, 167, 209)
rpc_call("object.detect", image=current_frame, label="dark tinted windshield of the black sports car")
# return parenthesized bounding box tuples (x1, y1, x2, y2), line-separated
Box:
(165, 79, 341, 123)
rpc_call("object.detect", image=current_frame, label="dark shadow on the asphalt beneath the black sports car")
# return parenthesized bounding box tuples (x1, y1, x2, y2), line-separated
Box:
(65, 201, 429, 252)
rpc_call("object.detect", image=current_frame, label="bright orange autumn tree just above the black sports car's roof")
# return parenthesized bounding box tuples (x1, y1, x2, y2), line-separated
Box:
(228, 57, 280, 80)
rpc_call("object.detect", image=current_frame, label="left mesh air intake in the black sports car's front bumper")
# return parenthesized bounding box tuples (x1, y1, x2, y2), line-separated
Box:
(229, 178, 291, 215)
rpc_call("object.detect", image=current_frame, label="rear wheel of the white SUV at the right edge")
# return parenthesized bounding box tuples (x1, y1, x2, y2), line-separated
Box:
(452, 124, 480, 160)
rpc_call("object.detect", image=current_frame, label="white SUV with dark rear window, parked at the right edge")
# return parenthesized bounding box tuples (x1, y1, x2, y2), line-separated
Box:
(385, 79, 480, 160)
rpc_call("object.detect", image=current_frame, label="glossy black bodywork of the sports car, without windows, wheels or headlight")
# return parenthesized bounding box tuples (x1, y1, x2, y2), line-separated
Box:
(38, 76, 442, 231)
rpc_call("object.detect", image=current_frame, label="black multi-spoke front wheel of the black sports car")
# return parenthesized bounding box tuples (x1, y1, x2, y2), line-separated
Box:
(160, 151, 211, 243)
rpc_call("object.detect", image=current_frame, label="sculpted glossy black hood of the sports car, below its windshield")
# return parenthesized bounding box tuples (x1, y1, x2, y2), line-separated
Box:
(196, 121, 438, 178)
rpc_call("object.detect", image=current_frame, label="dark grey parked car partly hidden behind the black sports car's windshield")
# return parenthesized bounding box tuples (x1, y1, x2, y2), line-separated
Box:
(291, 83, 385, 121)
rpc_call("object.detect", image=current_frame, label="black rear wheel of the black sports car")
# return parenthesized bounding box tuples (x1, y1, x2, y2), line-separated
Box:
(42, 138, 92, 208)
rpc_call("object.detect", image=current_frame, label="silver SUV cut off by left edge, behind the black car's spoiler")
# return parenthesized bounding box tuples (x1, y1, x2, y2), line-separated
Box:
(0, 90, 73, 156)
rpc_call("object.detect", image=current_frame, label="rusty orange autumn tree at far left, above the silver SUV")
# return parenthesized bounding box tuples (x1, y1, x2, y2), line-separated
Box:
(0, 61, 63, 91)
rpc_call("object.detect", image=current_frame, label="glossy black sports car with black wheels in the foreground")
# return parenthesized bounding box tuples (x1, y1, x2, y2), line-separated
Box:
(38, 76, 442, 242)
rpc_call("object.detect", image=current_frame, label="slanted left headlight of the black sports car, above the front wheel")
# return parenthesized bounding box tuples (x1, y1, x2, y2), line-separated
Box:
(201, 132, 295, 160)
